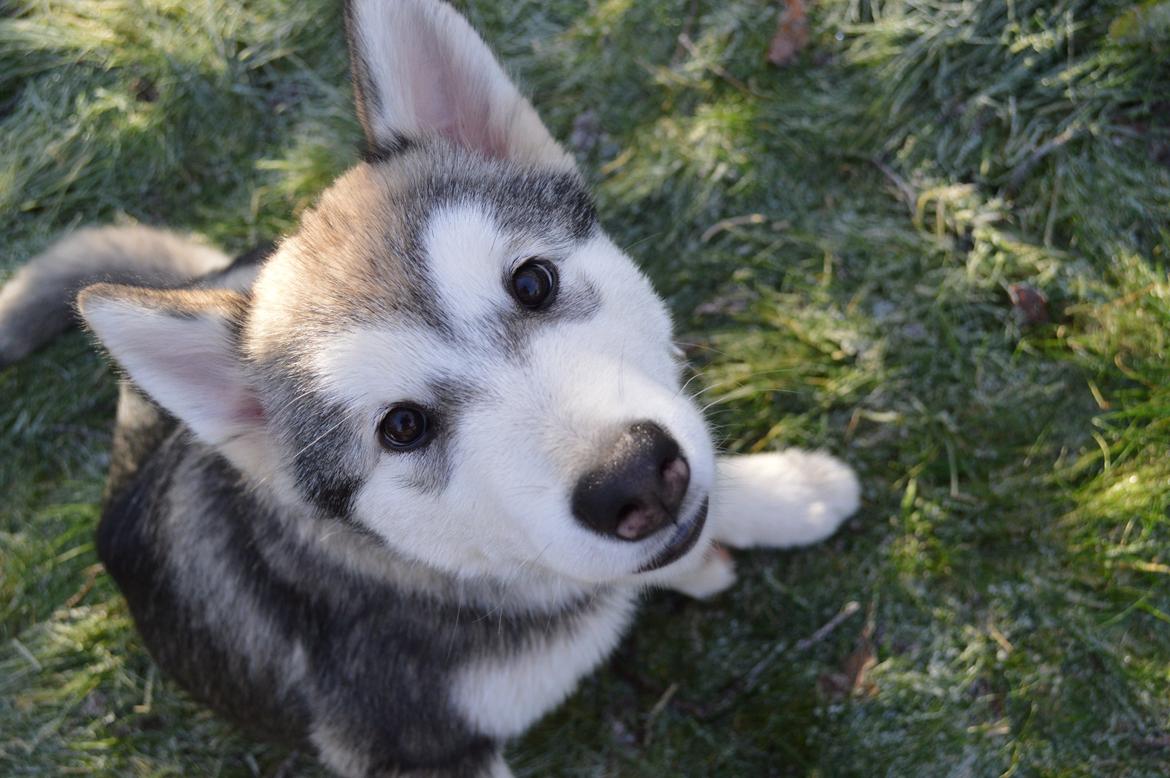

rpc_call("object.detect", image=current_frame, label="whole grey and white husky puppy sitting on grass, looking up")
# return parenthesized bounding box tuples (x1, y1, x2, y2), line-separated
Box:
(0, 0, 859, 777)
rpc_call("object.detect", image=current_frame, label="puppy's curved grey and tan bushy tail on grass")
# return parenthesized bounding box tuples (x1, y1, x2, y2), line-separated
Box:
(0, 226, 230, 370)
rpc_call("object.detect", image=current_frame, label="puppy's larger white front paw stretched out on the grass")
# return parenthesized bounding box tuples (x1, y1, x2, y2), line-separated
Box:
(711, 449, 861, 548)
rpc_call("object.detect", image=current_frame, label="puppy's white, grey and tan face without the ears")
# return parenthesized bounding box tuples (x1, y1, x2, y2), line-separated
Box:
(247, 147, 713, 581)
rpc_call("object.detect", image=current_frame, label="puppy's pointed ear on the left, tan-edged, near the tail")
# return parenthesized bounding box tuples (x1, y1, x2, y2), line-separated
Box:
(77, 283, 264, 446)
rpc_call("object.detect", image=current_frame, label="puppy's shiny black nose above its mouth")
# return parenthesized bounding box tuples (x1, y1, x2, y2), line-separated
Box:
(572, 421, 690, 541)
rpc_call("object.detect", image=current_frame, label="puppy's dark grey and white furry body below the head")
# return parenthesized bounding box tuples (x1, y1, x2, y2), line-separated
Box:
(98, 387, 632, 774)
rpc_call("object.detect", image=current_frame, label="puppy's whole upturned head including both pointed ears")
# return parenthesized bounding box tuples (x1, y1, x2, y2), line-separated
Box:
(82, 0, 714, 583)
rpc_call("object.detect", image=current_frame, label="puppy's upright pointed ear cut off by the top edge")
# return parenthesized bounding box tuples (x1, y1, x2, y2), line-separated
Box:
(345, 0, 576, 170)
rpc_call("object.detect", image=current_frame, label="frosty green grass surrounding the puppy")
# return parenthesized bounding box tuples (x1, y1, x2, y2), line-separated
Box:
(0, 0, 1170, 777)
